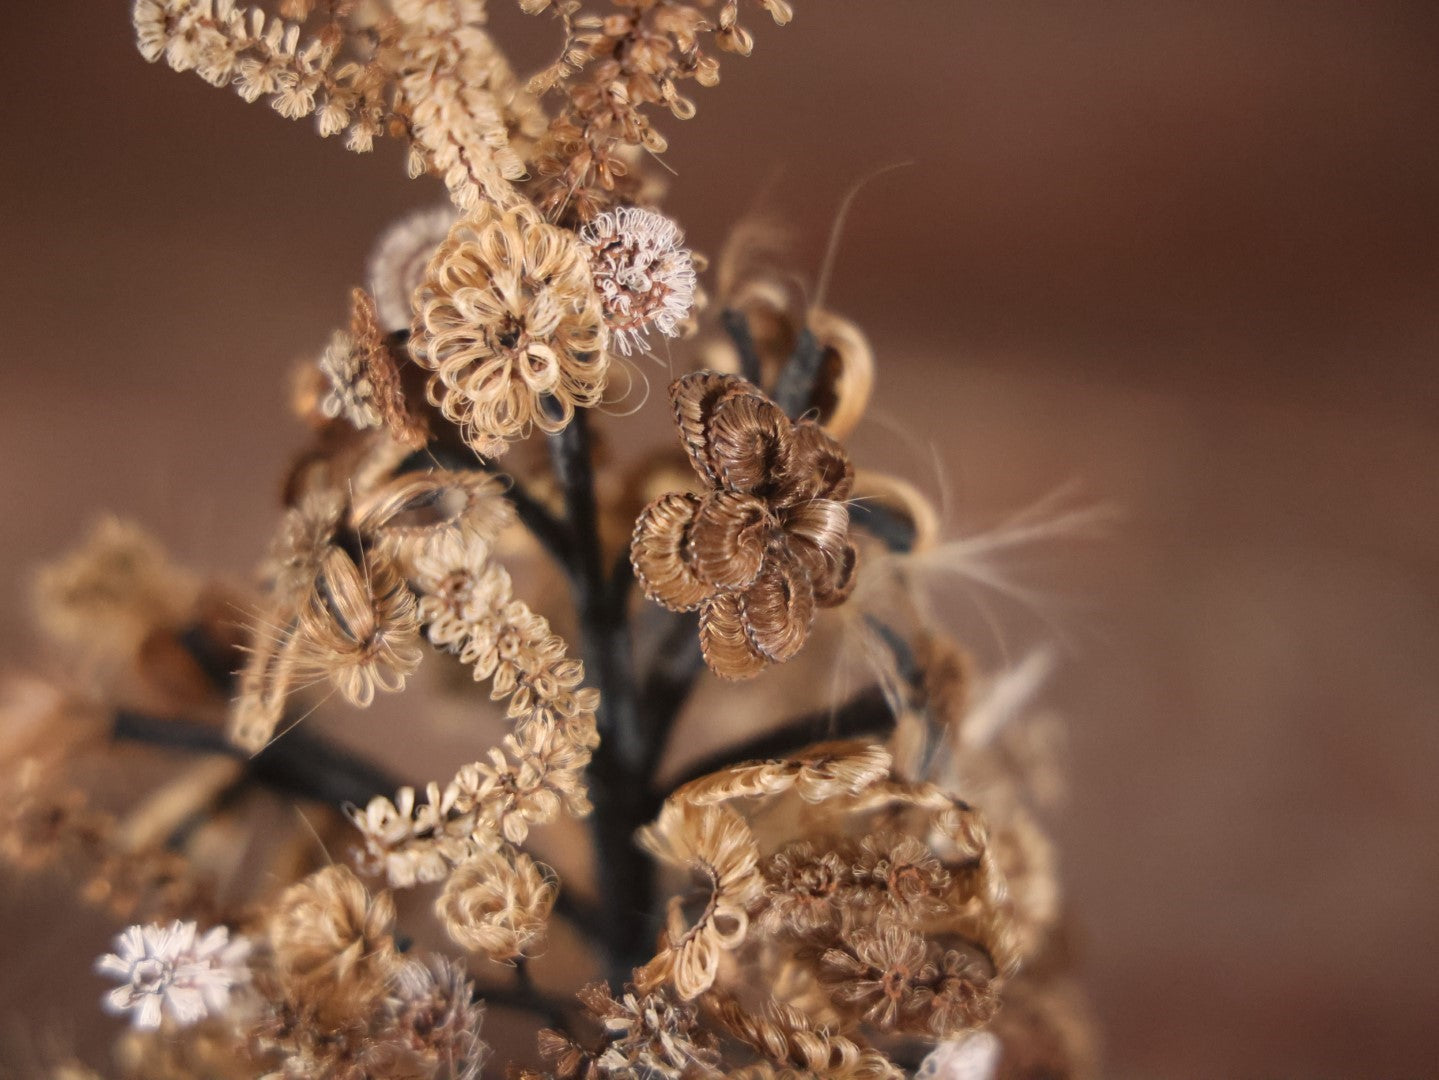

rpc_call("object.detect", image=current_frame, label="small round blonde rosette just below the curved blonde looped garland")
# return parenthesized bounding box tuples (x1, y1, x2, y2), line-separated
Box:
(435, 850, 560, 962)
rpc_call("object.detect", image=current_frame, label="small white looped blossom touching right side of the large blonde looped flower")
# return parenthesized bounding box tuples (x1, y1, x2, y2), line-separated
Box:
(580, 207, 695, 357)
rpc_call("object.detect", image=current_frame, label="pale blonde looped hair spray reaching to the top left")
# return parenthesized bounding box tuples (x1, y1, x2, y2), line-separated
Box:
(132, 0, 544, 209)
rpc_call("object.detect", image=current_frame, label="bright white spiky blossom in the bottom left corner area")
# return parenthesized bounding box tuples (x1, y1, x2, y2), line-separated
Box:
(95, 920, 250, 1030)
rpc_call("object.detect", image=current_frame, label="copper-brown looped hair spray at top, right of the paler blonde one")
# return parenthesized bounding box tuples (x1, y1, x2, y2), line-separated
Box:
(521, 0, 793, 221)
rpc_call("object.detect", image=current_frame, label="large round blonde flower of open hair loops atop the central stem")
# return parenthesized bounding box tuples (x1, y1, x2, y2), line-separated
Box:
(410, 209, 609, 457)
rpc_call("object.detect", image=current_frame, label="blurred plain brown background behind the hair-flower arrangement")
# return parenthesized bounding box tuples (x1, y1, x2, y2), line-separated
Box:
(0, 0, 1439, 1077)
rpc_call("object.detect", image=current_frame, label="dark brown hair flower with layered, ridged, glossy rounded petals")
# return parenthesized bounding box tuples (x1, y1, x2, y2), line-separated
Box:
(630, 371, 858, 679)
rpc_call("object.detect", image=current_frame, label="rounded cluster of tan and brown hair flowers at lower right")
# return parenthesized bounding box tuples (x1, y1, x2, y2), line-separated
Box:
(636, 743, 1020, 1076)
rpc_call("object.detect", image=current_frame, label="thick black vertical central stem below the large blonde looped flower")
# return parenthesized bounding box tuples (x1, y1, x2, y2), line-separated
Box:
(550, 411, 655, 988)
